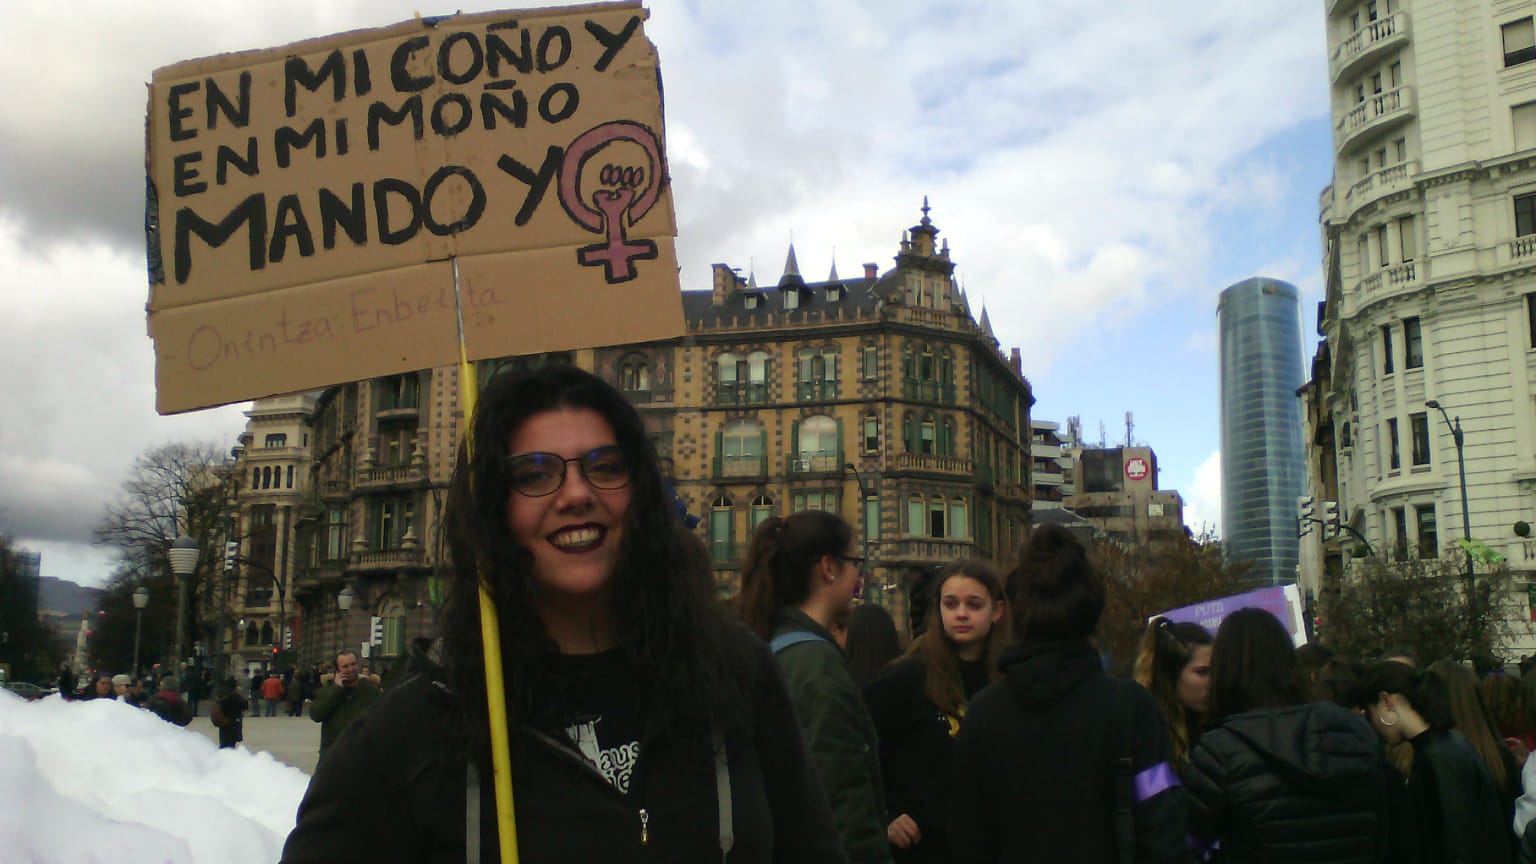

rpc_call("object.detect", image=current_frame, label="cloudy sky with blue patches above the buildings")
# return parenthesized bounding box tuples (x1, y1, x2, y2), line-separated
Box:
(0, 0, 1330, 584)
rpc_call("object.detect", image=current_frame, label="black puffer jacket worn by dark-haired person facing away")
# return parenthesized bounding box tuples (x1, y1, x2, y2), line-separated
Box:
(1184, 703, 1390, 864)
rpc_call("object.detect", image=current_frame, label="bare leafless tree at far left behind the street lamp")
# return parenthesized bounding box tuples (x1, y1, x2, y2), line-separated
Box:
(95, 443, 238, 658)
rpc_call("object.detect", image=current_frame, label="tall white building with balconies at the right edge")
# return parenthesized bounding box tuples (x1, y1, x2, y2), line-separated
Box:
(1304, 0, 1536, 650)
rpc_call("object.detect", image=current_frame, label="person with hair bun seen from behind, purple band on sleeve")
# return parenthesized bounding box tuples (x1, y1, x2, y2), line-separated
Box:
(949, 524, 1192, 864)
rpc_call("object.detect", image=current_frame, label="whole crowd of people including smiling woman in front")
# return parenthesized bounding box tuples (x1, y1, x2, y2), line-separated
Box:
(125, 358, 1517, 864)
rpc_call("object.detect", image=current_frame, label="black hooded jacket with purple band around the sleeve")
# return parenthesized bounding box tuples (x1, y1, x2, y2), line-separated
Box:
(949, 641, 1193, 864)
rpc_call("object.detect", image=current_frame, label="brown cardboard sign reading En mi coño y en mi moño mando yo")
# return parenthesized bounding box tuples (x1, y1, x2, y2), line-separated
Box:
(146, 3, 684, 414)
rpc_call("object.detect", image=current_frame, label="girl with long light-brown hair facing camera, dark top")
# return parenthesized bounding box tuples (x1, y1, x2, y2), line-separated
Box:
(865, 558, 1008, 862)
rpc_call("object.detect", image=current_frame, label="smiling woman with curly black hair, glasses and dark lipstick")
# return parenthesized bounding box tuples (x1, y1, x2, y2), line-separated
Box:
(283, 364, 840, 862)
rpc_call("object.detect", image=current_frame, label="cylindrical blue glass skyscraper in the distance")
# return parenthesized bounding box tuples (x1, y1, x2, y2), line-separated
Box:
(1217, 277, 1306, 584)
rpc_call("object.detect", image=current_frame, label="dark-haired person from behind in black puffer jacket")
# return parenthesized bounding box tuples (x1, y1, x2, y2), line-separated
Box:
(1184, 609, 1395, 864)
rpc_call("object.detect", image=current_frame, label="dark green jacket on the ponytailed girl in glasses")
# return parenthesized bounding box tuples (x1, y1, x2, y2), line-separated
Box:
(774, 609, 891, 864)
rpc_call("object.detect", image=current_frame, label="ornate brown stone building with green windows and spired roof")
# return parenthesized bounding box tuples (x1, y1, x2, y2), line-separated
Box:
(222, 204, 1034, 667)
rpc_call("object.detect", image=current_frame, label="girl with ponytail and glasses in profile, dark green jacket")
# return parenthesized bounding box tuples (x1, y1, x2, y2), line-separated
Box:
(737, 510, 891, 864)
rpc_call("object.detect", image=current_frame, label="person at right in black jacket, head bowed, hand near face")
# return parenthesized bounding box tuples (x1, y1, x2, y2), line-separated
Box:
(1359, 660, 1514, 864)
